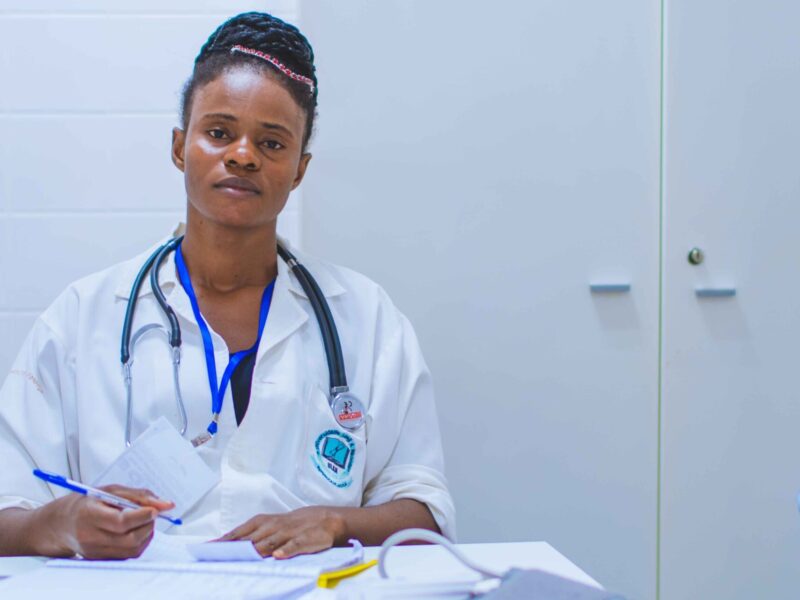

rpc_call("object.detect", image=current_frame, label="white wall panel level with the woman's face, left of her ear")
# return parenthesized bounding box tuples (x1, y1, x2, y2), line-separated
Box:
(0, 115, 184, 213)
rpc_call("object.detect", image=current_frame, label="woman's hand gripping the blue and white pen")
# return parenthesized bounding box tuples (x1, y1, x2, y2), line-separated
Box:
(32, 485, 175, 559)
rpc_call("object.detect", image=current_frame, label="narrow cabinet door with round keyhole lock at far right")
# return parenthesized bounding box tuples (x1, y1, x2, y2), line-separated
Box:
(661, 0, 800, 600)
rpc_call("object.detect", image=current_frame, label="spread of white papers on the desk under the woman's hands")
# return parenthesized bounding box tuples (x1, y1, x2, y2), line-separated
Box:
(0, 535, 364, 600)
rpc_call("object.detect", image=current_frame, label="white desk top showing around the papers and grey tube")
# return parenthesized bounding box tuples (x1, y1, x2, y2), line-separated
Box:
(0, 542, 599, 591)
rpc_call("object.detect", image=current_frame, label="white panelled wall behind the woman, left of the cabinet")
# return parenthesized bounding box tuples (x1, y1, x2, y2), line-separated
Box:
(0, 0, 300, 378)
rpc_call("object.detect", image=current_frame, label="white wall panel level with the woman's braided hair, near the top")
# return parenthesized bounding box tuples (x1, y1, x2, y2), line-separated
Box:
(0, 15, 245, 113)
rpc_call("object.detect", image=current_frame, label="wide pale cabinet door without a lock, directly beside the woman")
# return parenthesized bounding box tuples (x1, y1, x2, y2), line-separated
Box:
(302, 0, 660, 599)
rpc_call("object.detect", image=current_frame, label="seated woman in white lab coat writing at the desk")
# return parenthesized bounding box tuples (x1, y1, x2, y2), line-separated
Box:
(0, 13, 453, 558)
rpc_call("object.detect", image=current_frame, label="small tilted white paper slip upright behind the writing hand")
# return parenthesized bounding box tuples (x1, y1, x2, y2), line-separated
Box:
(93, 416, 218, 528)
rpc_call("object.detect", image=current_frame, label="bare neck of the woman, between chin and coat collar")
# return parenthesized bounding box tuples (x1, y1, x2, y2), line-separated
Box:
(181, 214, 278, 293)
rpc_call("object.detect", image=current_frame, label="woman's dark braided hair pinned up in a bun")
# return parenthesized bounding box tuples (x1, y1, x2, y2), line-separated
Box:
(180, 12, 317, 151)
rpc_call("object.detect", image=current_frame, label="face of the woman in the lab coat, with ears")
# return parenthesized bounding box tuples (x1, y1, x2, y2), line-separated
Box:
(172, 67, 311, 228)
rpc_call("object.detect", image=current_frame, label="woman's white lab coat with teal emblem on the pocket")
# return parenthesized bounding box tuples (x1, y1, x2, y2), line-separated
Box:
(0, 238, 455, 538)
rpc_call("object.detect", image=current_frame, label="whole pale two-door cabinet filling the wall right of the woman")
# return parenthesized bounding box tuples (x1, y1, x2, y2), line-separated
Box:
(302, 0, 800, 600)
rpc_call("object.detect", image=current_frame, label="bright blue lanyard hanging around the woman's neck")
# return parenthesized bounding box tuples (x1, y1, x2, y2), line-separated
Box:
(175, 246, 275, 435)
